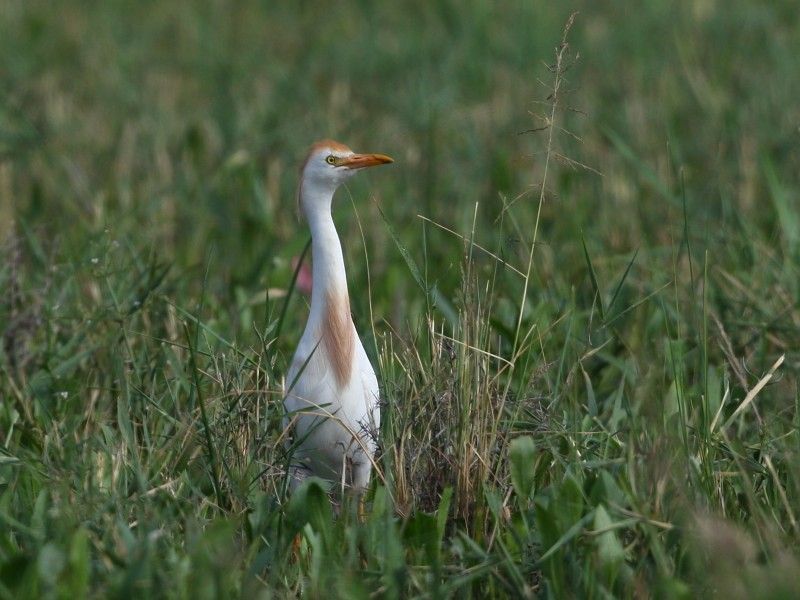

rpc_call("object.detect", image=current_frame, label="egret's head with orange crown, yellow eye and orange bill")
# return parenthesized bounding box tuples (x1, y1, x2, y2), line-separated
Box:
(299, 140, 394, 210)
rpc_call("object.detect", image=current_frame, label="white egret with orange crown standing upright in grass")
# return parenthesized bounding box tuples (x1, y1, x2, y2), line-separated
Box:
(284, 140, 393, 493)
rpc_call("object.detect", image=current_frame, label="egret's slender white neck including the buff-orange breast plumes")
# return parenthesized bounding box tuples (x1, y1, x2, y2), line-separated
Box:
(301, 180, 355, 387)
